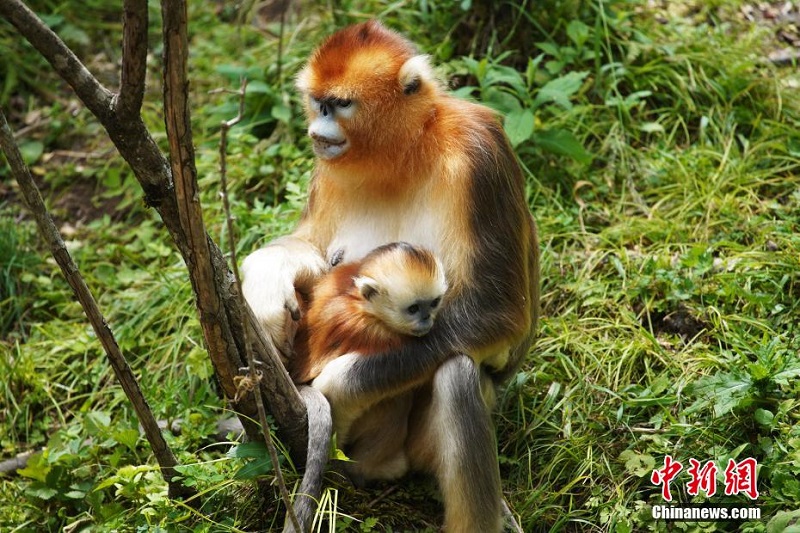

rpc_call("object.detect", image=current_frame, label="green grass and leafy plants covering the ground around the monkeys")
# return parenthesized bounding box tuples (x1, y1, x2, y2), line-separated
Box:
(0, 0, 800, 532)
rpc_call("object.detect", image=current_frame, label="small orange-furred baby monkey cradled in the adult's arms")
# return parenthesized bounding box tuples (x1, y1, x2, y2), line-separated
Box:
(290, 242, 447, 386)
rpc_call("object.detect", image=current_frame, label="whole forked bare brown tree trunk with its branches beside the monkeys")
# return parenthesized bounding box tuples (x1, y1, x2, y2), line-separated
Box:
(0, 0, 308, 470)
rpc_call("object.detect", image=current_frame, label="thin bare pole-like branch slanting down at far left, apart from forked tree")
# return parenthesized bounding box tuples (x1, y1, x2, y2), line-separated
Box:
(0, 110, 195, 497)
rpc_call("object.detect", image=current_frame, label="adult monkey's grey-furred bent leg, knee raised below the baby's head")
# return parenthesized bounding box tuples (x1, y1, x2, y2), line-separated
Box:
(409, 355, 502, 533)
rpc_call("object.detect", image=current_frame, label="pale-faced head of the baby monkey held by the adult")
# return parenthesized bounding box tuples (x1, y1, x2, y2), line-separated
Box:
(353, 242, 447, 337)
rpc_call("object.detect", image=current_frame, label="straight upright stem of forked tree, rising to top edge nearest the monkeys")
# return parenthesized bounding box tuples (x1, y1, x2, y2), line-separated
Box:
(156, 1, 307, 462)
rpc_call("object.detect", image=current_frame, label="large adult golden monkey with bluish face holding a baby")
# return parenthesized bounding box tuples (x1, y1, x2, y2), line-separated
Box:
(242, 21, 539, 532)
